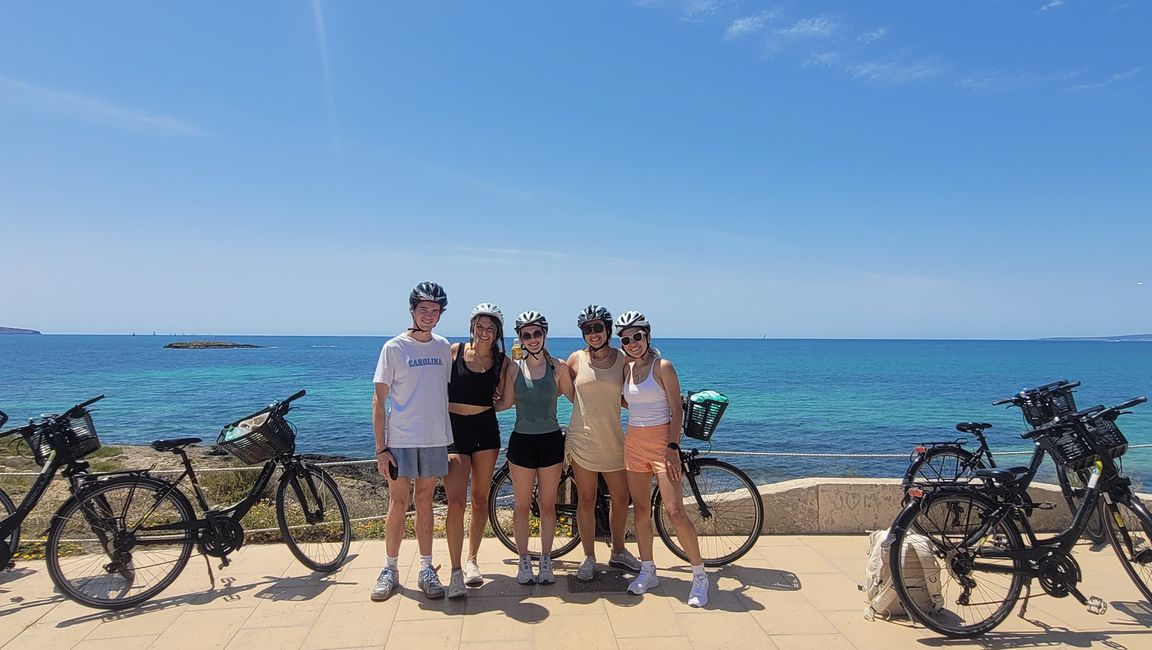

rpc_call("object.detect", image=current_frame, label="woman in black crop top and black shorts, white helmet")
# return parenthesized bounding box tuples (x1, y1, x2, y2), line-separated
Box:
(444, 303, 508, 598)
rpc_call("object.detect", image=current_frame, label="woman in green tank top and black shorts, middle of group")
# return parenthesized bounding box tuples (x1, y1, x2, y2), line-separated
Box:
(497, 311, 573, 584)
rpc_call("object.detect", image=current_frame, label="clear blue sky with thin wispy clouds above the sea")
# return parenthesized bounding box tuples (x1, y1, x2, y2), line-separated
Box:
(0, 0, 1152, 338)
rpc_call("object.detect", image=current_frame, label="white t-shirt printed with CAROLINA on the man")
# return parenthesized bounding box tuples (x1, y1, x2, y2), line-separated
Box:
(373, 332, 452, 448)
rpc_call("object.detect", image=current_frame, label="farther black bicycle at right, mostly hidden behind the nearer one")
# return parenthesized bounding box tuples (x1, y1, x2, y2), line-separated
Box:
(903, 379, 1106, 543)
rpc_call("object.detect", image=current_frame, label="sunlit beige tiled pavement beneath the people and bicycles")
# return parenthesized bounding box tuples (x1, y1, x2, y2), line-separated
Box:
(0, 536, 1152, 650)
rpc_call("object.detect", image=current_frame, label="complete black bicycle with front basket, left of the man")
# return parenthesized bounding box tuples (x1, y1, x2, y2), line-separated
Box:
(46, 391, 351, 610)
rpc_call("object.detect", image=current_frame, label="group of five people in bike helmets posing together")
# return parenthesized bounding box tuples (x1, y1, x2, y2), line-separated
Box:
(372, 282, 708, 606)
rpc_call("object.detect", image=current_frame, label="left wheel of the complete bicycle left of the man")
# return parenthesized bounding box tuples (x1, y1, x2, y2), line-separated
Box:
(45, 476, 196, 610)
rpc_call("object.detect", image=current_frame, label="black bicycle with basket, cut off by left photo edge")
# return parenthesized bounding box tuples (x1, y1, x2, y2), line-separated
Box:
(0, 395, 107, 570)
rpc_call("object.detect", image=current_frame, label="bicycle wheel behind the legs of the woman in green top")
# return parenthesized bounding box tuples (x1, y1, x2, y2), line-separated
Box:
(488, 463, 579, 559)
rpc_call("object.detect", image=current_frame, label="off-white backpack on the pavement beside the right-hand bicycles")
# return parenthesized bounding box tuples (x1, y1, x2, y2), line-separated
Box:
(859, 529, 943, 620)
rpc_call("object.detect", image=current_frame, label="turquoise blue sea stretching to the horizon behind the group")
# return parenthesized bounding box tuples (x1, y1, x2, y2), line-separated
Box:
(0, 335, 1152, 482)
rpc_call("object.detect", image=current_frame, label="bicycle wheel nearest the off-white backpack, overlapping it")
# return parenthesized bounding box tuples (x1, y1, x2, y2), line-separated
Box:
(888, 490, 1025, 638)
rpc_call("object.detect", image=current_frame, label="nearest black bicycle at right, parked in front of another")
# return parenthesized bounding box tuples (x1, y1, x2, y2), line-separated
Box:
(889, 398, 1152, 637)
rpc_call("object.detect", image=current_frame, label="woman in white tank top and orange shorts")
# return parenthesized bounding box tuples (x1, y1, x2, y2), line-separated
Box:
(616, 311, 708, 607)
